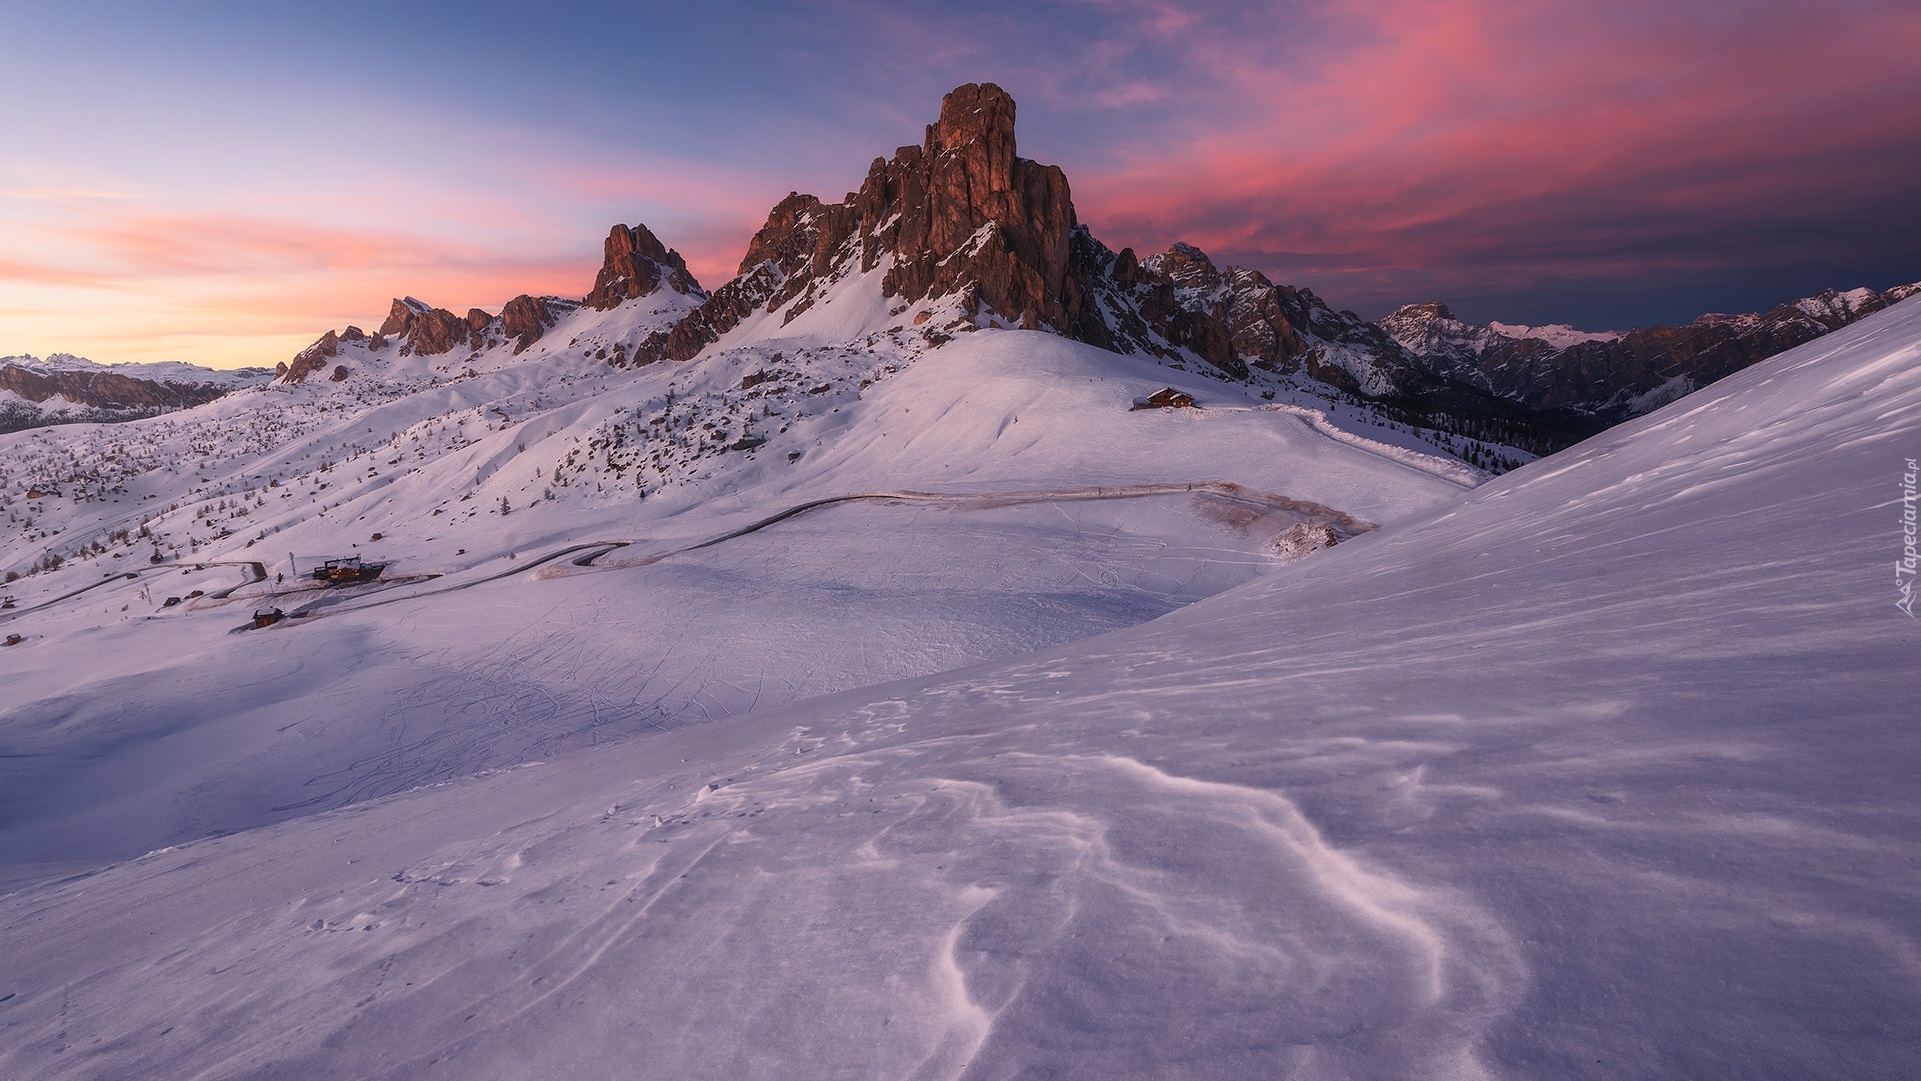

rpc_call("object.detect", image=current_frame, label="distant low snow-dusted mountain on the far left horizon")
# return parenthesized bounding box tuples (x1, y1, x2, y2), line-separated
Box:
(0, 353, 273, 432)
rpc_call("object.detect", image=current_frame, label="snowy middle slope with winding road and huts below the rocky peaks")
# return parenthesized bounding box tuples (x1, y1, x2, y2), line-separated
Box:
(0, 264, 1481, 879)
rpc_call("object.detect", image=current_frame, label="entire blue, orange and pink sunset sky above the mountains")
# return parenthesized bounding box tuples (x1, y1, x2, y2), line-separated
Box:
(0, 0, 1921, 367)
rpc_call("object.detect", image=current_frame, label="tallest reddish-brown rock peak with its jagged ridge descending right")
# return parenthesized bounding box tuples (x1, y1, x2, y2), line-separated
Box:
(636, 83, 1444, 390)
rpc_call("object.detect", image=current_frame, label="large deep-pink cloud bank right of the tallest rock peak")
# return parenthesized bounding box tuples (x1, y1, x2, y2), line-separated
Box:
(1076, 0, 1921, 309)
